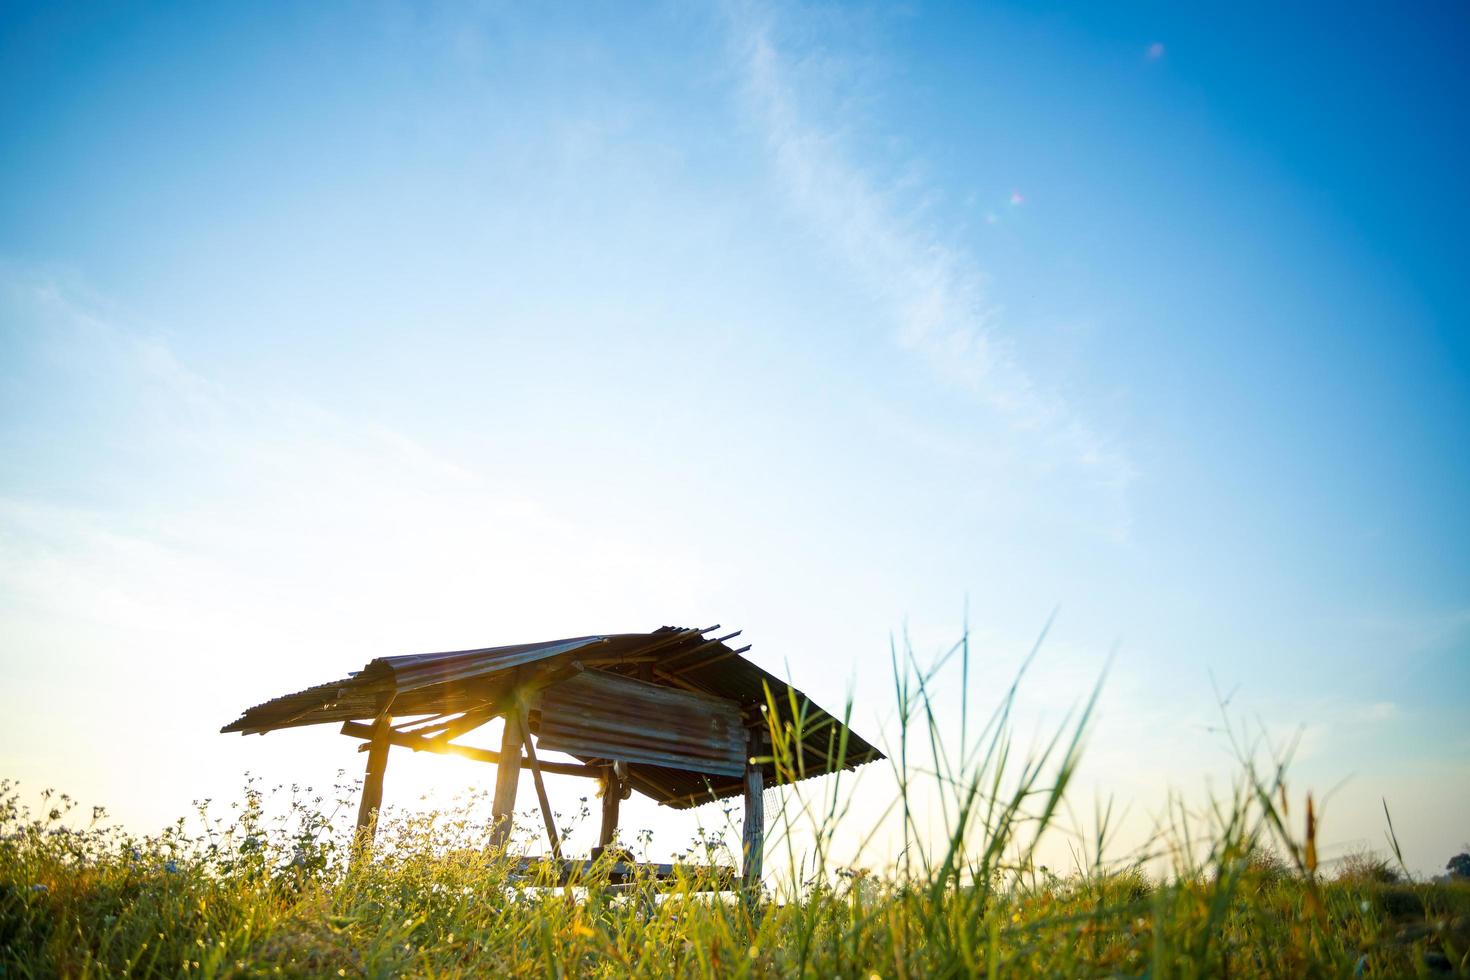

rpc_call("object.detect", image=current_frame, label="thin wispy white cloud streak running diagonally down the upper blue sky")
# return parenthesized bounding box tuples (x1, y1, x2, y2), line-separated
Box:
(731, 6, 1135, 533)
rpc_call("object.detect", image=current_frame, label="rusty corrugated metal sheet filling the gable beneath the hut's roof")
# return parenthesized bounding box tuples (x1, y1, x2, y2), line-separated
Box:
(538, 670, 747, 776)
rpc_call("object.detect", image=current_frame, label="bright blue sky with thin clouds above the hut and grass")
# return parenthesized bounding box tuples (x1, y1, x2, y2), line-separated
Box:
(0, 3, 1470, 870)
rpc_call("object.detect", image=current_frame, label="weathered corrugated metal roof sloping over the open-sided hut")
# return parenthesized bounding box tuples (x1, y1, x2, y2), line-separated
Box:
(221, 626, 883, 808)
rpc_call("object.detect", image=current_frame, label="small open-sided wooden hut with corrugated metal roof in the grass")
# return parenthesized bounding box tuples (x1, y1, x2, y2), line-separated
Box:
(221, 626, 883, 884)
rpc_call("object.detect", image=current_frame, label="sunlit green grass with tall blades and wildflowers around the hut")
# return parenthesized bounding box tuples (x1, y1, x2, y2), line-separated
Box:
(0, 631, 1470, 977)
